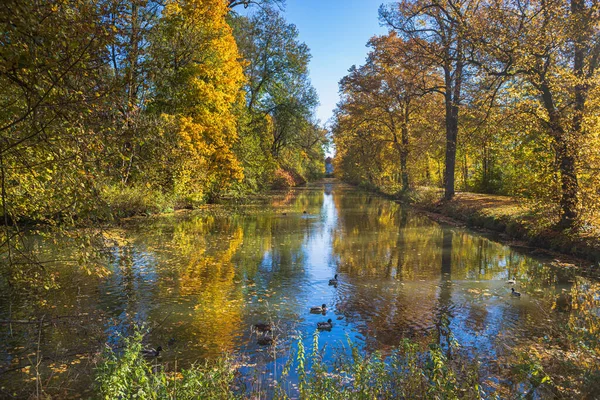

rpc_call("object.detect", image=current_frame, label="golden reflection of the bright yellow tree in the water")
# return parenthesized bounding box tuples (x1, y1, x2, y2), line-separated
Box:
(103, 215, 244, 357)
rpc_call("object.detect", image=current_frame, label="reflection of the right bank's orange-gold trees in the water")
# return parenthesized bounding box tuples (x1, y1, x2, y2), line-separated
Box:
(333, 188, 592, 356)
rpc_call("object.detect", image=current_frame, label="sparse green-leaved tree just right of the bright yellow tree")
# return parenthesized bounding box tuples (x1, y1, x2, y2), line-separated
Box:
(232, 6, 325, 184)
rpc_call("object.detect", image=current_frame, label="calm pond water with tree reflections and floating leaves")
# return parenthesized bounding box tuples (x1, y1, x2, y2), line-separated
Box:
(0, 180, 597, 397)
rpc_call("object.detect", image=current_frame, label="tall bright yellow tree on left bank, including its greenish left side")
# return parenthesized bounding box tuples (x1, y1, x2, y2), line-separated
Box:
(151, 0, 244, 199)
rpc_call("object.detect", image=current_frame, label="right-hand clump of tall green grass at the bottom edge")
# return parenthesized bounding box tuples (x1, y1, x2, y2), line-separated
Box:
(275, 334, 483, 400)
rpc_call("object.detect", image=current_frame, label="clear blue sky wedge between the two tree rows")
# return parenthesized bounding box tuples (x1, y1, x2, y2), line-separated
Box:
(284, 0, 387, 124)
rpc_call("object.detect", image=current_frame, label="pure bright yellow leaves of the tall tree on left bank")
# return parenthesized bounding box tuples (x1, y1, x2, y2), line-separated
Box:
(162, 0, 245, 199)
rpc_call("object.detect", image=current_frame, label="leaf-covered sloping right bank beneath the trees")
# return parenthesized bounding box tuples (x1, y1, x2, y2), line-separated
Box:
(406, 189, 600, 263)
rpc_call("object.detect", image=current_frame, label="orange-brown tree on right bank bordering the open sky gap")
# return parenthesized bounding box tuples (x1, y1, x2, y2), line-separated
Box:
(335, 32, 437, 191)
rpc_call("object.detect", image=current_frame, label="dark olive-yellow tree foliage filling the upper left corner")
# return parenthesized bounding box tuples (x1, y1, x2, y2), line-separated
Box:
(0, 0, 113, 225)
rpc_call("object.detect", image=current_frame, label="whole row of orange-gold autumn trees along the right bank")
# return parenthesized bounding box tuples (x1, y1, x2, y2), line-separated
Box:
(334, 0, 600, 229)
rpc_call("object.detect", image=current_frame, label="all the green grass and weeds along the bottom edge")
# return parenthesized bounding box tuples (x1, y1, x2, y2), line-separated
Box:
(96, 333, 484, 400)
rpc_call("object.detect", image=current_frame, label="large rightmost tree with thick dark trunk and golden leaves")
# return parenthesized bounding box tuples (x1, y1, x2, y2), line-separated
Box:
(473, 0, 600, 228)
